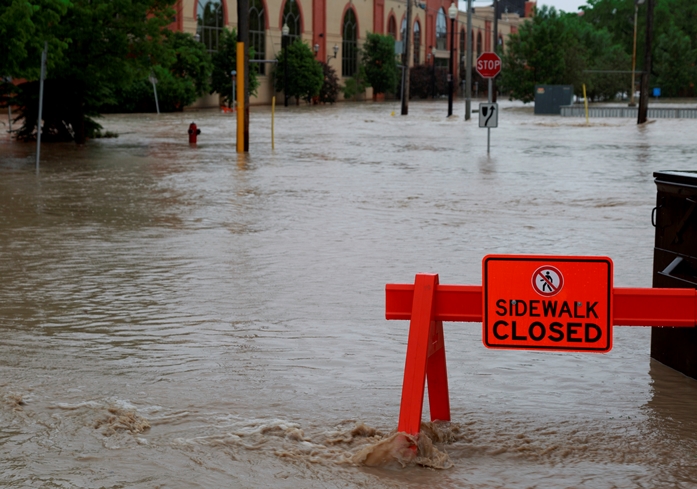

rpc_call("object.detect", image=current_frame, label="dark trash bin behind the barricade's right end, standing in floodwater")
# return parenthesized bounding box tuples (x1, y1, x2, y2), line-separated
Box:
(651, 171, 697, 379)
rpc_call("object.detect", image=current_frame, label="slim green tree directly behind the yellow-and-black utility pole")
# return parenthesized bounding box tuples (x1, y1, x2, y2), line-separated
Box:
(211, 29, 260, 107)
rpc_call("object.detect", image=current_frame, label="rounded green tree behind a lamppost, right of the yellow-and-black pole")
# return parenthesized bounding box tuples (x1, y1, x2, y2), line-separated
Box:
(275, 40, 324, 102)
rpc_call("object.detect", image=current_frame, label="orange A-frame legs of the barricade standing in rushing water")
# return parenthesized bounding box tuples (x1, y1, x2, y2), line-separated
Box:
(398, 273, 450, 435)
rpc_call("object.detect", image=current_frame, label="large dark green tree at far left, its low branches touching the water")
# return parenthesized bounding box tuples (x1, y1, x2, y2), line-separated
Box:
(9, 0, 174, 143)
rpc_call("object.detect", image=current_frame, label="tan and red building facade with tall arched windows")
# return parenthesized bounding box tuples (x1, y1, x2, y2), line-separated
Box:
(172, 0, 533, 106)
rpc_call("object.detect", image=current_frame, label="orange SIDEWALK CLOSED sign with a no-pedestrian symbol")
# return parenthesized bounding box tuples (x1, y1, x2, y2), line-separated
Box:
(482, 255, 613, 353)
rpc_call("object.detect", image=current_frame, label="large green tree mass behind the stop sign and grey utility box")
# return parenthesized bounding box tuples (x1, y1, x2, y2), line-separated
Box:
(500, 0, 697, 101)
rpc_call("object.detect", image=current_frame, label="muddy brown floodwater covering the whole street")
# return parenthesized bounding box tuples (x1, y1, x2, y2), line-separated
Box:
(0, 101, 697, 489)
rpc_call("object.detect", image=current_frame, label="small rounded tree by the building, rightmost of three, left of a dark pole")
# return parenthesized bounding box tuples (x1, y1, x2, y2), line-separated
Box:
(361, 33, 397, 93)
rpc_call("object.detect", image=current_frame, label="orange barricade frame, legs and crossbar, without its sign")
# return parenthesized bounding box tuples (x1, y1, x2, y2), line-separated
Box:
(385, 257, 697, 435)
